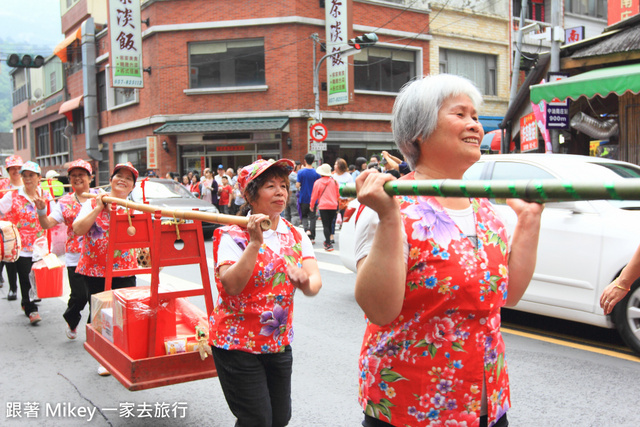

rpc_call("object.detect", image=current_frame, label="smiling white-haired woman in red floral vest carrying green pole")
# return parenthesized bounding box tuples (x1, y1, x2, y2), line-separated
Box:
(355, 74, 543, 426)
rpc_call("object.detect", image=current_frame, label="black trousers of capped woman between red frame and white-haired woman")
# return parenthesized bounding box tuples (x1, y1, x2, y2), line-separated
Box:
(211, 346, 293, 427)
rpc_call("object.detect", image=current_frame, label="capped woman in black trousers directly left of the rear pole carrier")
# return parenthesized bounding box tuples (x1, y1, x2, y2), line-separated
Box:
(35, 159, 99, 340)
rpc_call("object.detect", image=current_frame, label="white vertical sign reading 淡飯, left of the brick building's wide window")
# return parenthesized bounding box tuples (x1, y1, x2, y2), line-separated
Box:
(109, 0, 144, 88)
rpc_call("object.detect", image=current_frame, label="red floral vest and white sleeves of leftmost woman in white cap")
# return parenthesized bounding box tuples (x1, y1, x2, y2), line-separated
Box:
(0, 187, 53, 256)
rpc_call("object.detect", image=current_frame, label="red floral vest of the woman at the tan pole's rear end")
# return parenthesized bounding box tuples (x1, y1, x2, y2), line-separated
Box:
(76, 199, 138, 277)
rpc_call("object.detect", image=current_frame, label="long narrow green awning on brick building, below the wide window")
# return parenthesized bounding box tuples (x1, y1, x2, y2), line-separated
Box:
(154, 117, 289, 135)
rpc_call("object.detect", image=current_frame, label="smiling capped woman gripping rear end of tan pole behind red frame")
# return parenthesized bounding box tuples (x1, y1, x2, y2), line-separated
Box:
(73, 162, 138, 375)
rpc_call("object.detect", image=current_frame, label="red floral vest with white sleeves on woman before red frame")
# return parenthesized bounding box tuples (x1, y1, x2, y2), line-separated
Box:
(209, 218, 302, 354)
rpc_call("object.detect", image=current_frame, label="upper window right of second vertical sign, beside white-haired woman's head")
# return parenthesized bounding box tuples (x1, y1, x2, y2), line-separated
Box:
(353, 47, 416, 92)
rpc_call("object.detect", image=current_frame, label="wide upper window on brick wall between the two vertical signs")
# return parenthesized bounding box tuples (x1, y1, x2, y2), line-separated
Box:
(189, 39, 265, 89)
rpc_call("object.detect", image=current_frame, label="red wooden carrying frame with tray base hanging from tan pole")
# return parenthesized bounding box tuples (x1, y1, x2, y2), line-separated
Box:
(84, 203, 217, 391)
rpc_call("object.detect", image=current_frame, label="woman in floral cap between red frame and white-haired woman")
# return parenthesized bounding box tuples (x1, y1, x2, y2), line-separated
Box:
(209, 159, 322, 427)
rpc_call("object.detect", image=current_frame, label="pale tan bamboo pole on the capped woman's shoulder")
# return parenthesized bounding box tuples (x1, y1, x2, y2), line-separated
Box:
(81, 193, 271, 230)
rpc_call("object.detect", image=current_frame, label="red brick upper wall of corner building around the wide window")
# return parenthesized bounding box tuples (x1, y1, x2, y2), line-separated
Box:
(98, 0, 429, 125)
